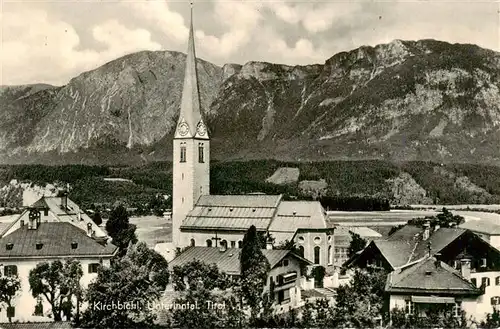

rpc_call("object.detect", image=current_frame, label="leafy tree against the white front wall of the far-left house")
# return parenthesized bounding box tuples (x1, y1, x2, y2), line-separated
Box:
(29, 259, 83, 321)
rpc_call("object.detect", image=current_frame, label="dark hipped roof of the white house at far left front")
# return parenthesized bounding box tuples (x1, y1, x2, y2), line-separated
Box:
(0, 222, 118, 259)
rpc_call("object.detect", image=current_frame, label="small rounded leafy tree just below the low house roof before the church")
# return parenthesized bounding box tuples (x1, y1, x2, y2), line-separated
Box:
(172, 259, 231, 291)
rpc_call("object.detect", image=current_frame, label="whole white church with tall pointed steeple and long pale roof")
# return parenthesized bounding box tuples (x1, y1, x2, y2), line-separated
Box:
(167, 5, 334, 268)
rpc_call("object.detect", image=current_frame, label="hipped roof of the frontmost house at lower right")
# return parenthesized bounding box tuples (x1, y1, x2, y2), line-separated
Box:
(385, 257, 481, 295)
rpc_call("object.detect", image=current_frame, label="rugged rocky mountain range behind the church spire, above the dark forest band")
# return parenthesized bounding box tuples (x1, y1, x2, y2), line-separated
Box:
(0, 40, 500, 165)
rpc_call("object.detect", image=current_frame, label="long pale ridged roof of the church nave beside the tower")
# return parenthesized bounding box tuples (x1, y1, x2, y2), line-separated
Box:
(181, 195, 281, 230)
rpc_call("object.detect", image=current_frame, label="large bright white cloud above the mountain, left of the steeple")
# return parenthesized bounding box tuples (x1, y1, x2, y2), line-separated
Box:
(0, 8, 161, 85)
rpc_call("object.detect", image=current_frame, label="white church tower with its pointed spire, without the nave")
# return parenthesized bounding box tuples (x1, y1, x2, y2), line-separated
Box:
(172, 4, 210, 247)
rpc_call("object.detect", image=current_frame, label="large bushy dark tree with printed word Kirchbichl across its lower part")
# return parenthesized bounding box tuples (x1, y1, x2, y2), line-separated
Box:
(80, 243, 168, 328)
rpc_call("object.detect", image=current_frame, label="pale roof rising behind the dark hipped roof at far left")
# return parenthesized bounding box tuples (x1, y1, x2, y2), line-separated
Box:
(0, 196, 107, 237)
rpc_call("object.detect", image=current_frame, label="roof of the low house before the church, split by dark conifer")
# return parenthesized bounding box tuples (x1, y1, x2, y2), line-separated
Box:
(168, 247, 310, 275)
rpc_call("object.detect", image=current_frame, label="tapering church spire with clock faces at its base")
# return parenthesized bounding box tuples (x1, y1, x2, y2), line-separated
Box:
(175, 2, 208, 139)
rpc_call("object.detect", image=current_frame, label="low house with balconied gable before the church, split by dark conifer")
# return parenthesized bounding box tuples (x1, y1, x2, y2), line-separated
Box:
(168, 247, 312, 312)
